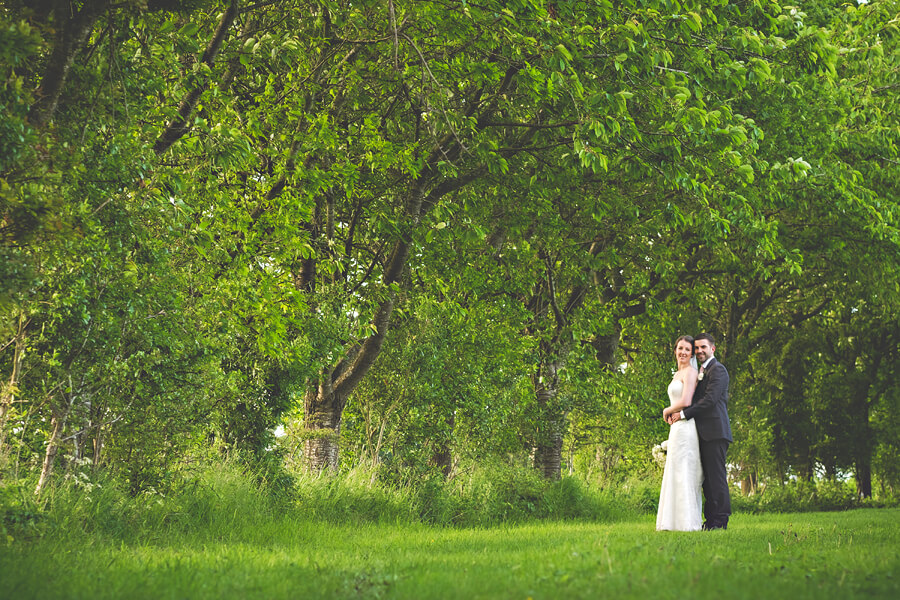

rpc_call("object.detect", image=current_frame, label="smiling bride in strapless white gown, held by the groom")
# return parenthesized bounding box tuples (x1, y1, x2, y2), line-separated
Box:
(656, 335, 703, 531)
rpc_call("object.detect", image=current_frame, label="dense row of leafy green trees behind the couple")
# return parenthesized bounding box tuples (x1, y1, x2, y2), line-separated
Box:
(0, 0, 898, 500)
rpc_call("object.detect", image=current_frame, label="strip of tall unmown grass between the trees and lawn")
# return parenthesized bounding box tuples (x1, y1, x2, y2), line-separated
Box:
(0, 454, 896, 543)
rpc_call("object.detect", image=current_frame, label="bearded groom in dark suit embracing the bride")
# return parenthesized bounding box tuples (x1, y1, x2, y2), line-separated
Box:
(670, 333, 732, 530)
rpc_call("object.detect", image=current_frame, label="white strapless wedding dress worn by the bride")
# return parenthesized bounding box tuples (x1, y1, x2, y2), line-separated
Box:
(656, 379, 703, 531)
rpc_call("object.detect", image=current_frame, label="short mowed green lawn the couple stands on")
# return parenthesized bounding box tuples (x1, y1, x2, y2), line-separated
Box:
(0, 509, 900, 600)
